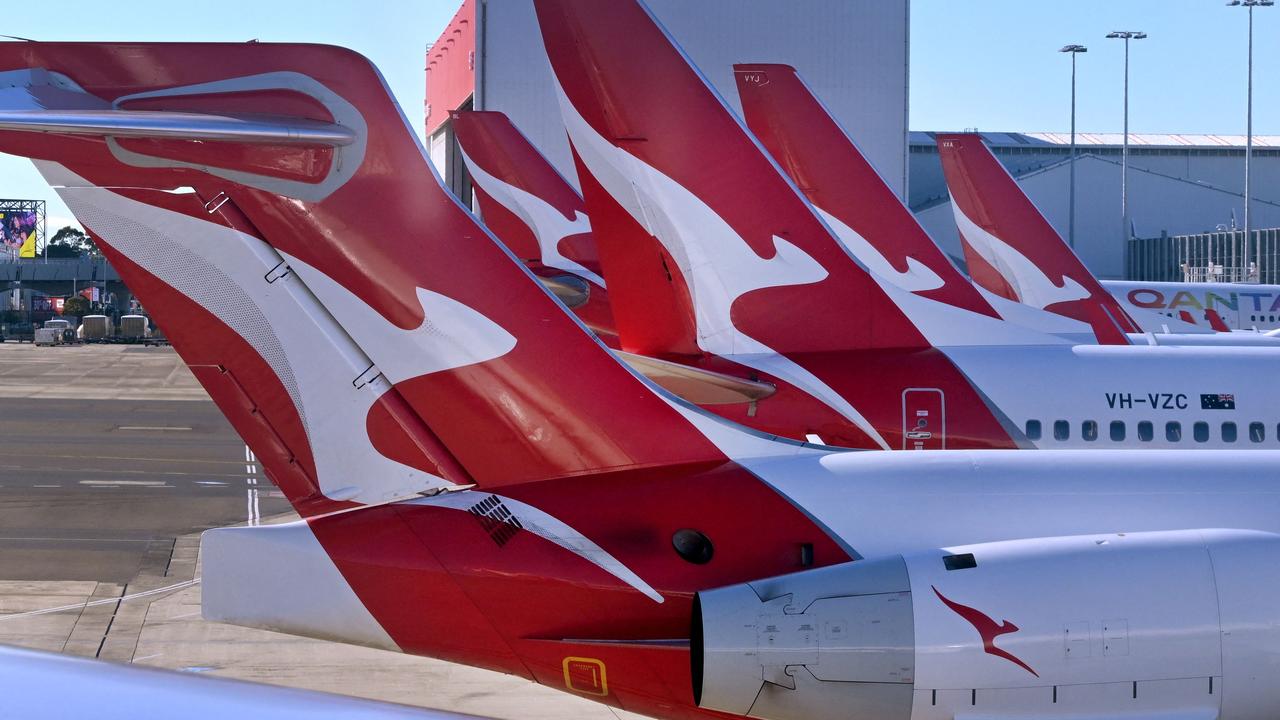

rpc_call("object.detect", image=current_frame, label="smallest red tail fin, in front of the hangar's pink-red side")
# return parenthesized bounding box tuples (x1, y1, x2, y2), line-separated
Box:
(453, 111, 617, 342)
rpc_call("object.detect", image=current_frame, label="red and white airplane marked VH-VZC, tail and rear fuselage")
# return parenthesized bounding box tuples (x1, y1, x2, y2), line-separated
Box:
(543, 1, 1280, 450)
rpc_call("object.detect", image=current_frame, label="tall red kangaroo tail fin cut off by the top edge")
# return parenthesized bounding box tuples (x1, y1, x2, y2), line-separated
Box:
(535, 0, 929, 355)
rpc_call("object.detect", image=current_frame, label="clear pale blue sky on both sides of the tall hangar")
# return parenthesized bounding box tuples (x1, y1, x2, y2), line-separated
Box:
(0, 0, 1280, 233)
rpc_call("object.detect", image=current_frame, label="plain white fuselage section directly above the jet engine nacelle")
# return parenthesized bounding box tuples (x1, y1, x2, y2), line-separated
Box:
(741, 450, 1280, 557)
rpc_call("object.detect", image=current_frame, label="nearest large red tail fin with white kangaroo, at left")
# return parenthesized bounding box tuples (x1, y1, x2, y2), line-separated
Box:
(0, 42, 742, 516)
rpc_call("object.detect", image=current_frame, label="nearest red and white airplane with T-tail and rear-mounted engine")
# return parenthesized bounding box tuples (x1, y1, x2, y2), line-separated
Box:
(0, 14, 1280, 720)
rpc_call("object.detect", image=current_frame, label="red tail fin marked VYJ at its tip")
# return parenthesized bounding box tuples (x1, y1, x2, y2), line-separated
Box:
(733, 64, 997, 318)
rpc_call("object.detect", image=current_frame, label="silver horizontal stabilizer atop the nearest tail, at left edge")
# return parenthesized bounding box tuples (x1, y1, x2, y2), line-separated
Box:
(0, 108, 356, 147)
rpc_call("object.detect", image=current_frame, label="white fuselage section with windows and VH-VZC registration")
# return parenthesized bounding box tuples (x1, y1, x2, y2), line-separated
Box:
(943, 345, 1280, 450)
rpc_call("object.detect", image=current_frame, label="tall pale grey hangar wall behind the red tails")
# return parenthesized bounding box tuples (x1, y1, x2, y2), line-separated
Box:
(428, 0, 910, 196)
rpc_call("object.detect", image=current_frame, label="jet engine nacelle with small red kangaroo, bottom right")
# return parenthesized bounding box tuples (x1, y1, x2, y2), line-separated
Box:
(691, 529, 1280, 720)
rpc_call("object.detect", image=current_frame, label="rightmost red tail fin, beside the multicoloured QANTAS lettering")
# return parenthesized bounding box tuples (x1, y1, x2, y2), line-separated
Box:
(937, 133, 1140, 345)
